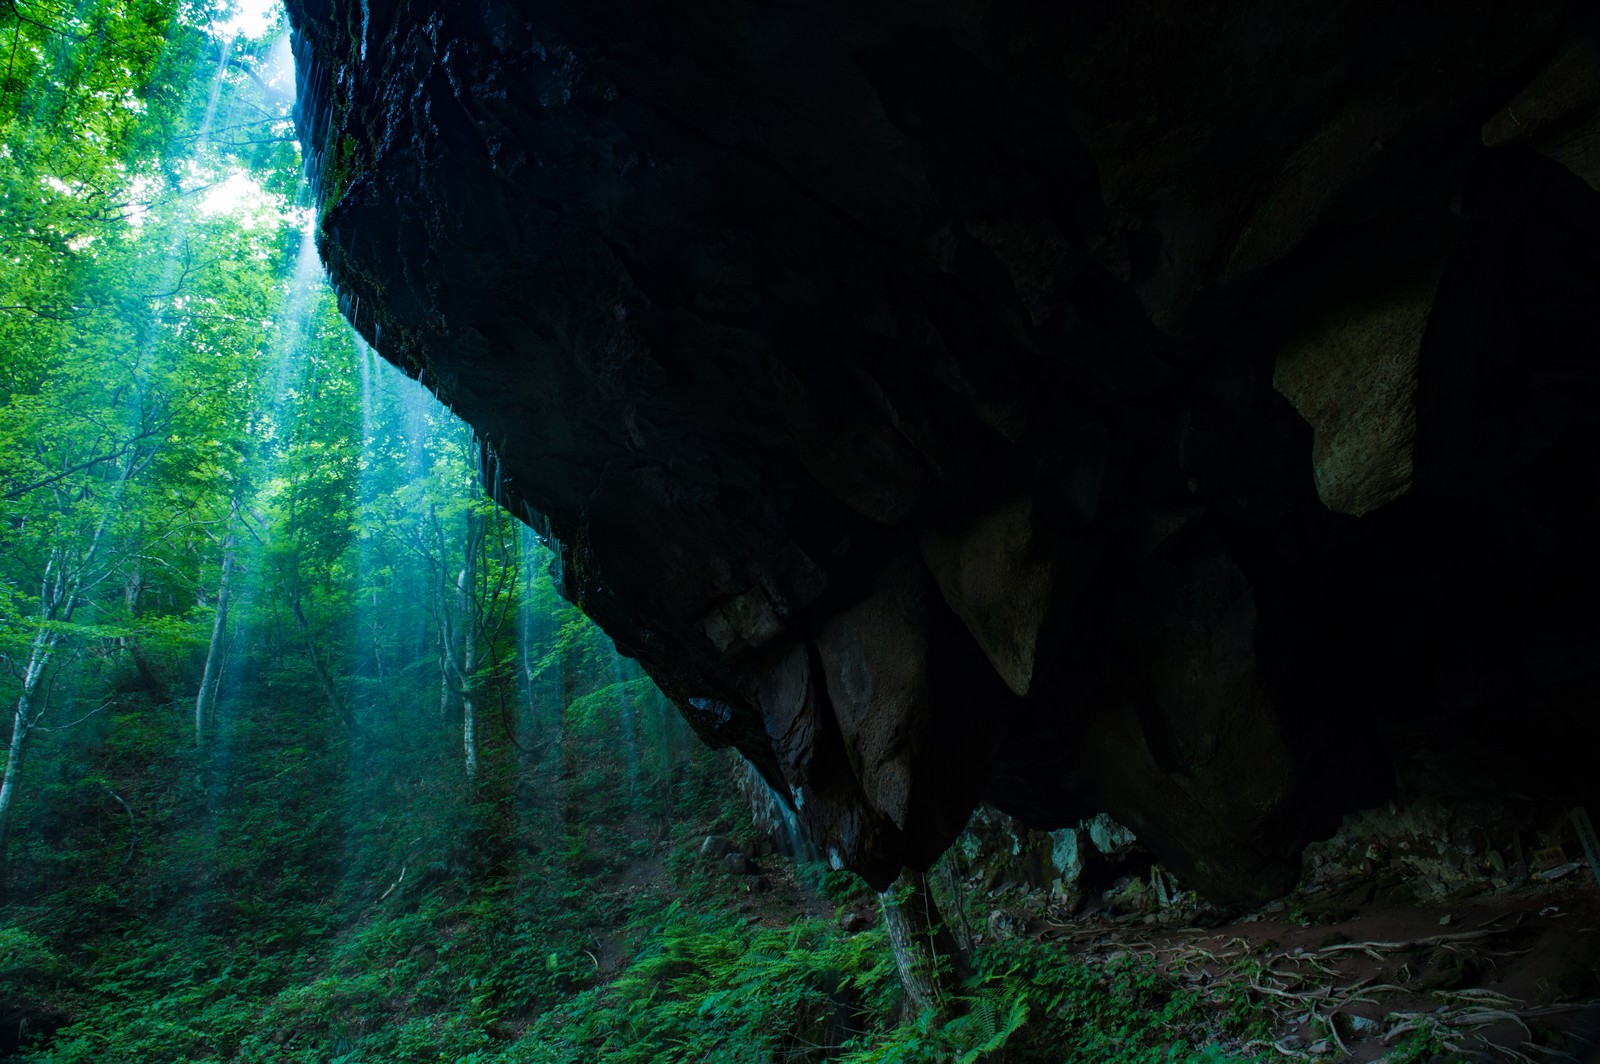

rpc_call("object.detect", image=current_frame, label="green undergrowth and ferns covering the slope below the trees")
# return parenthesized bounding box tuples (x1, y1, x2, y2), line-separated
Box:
(0, 665, 1262, 1064)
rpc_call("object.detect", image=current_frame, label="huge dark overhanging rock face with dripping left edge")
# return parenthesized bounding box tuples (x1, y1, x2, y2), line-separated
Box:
(290, 0, 1600, 901)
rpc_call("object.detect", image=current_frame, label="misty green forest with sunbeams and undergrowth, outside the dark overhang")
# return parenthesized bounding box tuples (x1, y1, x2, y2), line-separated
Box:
(0, 0, 1593, 1064)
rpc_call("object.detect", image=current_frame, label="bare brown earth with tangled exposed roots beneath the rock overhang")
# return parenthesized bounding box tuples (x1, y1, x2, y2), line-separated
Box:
(990, 872, 1600, 1064)
